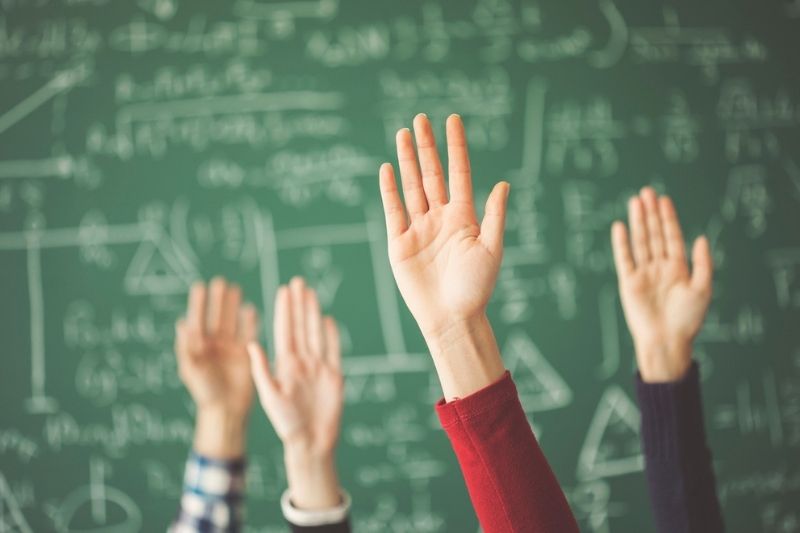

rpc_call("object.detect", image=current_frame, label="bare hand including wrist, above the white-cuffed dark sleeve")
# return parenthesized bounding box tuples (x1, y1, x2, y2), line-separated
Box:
(248, 278, 344, 509)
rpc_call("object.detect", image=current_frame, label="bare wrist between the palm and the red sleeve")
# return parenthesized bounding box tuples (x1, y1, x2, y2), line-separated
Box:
(423, 312, 505, 401)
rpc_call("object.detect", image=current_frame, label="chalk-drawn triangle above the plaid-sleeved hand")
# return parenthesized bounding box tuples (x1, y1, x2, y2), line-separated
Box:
(125, 234, 197, 294)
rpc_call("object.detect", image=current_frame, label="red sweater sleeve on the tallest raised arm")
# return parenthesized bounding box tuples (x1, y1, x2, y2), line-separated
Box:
(436, 372, 578, 533)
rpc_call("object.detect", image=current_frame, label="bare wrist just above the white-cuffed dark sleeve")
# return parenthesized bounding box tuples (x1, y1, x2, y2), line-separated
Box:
(283, 444, 341, 510)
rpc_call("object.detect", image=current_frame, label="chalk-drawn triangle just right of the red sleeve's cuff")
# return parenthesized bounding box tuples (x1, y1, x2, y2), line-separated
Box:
(503, 332, 572, 412)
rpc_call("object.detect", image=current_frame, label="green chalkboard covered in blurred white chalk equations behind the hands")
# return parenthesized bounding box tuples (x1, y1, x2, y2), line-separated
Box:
(0, 0, 800, 533)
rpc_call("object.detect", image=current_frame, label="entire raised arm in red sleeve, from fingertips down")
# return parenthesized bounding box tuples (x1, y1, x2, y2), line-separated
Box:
(380, 115, 578, 533)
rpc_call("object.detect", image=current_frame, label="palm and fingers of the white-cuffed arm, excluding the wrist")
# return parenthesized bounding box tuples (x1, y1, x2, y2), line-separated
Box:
(248, 278, 344, 453)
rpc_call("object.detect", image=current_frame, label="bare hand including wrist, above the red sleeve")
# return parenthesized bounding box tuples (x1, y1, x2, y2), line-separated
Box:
(380, 115, 509, 398)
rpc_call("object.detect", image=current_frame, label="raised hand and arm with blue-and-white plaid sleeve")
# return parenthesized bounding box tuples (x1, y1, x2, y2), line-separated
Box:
(172, 278, 258, 533)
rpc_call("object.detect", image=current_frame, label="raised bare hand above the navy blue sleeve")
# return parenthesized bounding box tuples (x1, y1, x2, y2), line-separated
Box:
(611, 187, 713, 382)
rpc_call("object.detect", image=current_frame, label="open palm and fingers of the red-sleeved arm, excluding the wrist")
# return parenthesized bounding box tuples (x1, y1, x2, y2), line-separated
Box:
(380, 115, 508, 333)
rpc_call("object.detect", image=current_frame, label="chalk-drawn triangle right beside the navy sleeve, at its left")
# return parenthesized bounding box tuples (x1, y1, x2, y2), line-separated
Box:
(577, 385, 644, 480)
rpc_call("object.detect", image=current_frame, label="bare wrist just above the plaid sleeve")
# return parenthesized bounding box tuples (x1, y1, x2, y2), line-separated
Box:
(194, 407, 247, 460)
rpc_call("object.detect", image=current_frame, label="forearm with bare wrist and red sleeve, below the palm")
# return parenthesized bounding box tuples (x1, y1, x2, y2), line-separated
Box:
(422, 314, 577, 533)
